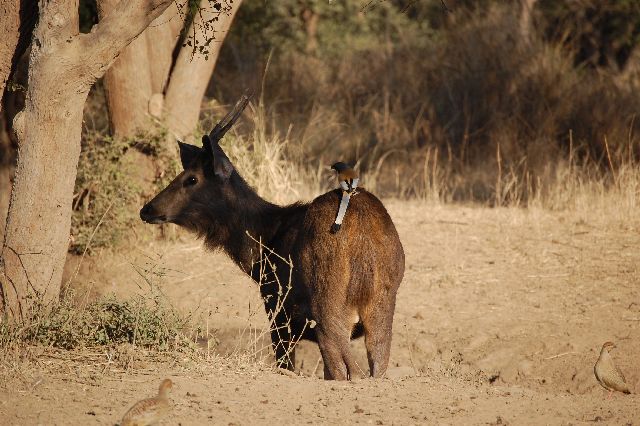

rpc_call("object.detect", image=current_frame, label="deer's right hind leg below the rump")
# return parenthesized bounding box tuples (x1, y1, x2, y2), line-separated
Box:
(362, 291, 396, 378)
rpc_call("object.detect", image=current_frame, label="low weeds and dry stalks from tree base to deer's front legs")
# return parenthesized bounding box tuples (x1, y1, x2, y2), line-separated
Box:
(0, 233, 308, 380)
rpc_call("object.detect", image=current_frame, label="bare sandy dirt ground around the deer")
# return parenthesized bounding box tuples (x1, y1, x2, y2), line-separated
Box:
(0, 200, 640, 425)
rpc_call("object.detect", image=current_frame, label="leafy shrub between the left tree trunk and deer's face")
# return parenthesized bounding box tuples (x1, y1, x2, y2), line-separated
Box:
(69, 126, 177, 254)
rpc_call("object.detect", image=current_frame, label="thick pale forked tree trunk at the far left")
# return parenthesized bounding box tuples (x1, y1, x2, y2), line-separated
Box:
(0, 0, 172, 319)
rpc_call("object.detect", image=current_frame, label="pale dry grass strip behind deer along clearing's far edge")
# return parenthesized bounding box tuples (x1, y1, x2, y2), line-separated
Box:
(192, 93, 640, 218)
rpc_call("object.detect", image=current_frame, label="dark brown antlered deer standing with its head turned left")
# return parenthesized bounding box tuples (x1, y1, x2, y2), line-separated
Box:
(140, 97, 404, 380)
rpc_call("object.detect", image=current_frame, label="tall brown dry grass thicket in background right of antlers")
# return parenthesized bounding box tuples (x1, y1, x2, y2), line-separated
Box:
(214, 2, 640, 209)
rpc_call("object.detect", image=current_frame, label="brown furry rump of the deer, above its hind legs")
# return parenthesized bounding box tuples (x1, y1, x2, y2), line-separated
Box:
(294, 189, 404, 306)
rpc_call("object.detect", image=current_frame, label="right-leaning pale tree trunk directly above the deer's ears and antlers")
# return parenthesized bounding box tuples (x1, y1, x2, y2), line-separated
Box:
(164, 0, 242, 146)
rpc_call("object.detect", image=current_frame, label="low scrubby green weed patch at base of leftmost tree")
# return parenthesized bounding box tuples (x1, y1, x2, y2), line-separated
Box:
(0, 256, 202, 354)
